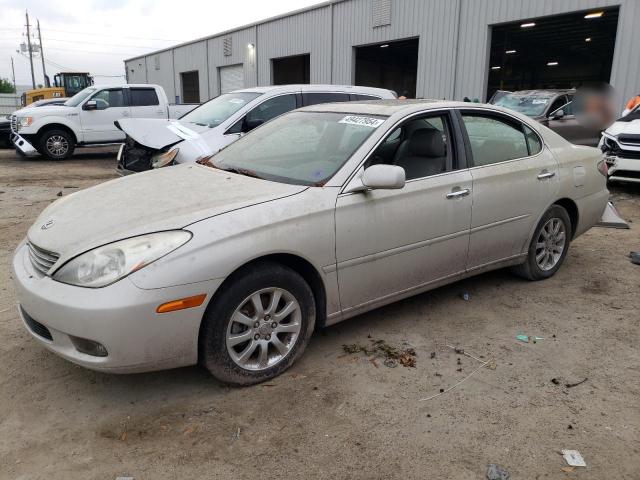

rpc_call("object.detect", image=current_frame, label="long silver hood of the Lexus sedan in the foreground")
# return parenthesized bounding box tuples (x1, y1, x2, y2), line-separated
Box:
(27, 164, 307, 261)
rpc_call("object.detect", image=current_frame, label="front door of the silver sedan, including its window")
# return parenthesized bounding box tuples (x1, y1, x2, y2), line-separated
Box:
(336, 113, 472, 314)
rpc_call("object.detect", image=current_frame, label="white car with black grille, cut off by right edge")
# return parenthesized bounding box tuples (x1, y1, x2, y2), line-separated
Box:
(598, 105, 640, 183)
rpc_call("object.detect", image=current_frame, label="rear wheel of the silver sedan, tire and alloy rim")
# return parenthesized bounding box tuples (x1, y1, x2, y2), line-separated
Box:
(514, 205, 572, 280)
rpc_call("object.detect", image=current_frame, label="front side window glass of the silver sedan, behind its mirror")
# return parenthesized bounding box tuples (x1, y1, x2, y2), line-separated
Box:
(365, 115, 453, 180)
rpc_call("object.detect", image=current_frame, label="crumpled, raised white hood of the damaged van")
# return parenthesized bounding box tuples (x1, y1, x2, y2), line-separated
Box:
(115, 118, 211, 150)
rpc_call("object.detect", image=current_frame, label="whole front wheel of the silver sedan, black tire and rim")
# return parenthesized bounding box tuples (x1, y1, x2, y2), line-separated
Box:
(200, 262, 315, 385)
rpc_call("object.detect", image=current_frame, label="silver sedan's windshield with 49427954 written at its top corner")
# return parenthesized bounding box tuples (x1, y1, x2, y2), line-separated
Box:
(210, 112, 386, 186)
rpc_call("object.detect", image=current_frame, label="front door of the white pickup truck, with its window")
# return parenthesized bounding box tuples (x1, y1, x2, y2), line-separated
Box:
(80, 88, 130, 143)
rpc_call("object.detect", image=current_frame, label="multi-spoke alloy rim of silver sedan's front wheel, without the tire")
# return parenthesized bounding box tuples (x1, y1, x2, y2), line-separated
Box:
(226, 287, 302, 371)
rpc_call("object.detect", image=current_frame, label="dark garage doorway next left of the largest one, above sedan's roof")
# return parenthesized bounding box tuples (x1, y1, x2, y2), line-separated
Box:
(355, 38, 418, 98)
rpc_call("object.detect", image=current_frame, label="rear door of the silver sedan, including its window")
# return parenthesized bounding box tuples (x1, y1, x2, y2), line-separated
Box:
(461, 109, 558, 270)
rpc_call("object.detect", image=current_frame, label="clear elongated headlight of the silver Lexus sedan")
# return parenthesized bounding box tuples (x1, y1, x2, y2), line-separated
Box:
(53, 230, 191, 288)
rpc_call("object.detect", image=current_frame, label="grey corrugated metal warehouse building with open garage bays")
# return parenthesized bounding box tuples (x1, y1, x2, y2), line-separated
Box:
(125, 0, 640, 107)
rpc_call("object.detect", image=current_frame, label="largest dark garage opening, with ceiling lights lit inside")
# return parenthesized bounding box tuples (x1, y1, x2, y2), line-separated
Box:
(487, 7, 618, 99)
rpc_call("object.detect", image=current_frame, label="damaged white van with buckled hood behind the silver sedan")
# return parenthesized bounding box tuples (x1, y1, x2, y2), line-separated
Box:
(115, 85, 396, 175)
